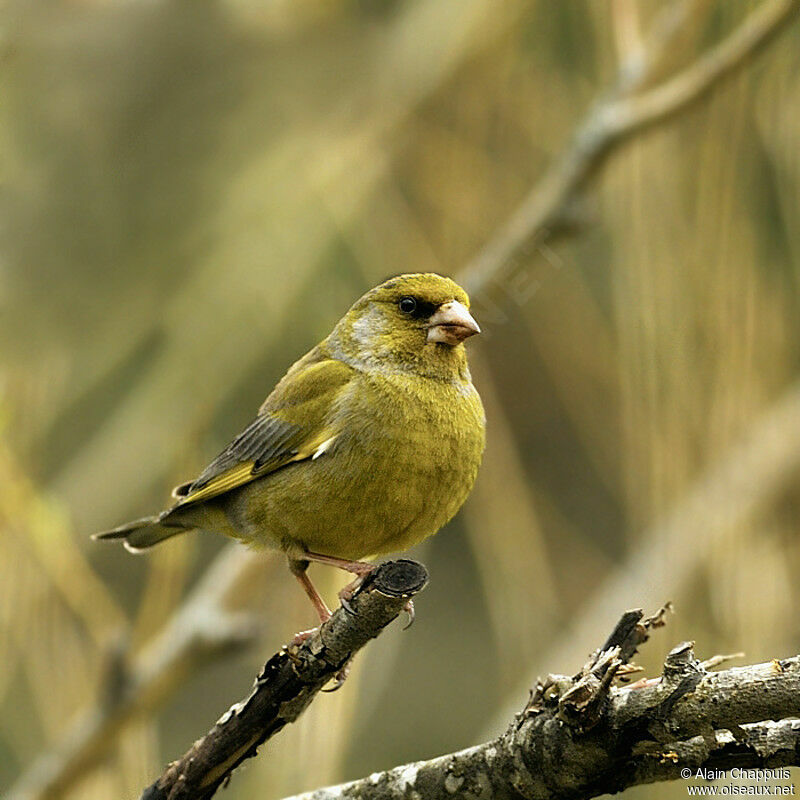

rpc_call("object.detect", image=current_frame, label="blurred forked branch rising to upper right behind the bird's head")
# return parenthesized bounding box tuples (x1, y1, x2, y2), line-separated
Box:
(459, 0, 800, 294)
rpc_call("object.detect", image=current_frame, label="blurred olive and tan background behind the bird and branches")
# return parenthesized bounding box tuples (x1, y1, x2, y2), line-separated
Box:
(0, 0, 800, 800)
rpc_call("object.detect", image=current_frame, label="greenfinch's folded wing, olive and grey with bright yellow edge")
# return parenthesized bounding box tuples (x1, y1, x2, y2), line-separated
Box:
(173, 351, 355, 506)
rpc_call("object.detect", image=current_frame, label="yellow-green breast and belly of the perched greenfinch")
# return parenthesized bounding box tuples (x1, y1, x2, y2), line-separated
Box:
(205, 372, 484, 559)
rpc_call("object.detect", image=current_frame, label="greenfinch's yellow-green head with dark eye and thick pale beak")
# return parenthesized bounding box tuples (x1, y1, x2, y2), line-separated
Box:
(329, 273, 480, 379)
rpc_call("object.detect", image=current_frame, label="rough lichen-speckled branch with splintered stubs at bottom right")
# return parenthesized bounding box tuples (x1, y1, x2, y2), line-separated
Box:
(284, 609, 800, 800)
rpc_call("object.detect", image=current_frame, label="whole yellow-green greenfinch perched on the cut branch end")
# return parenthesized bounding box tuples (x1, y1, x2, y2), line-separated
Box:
(94, 274, 485, 621)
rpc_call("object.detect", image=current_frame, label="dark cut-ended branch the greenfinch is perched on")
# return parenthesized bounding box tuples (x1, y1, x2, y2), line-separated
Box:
(142, 559, 428, 800)
